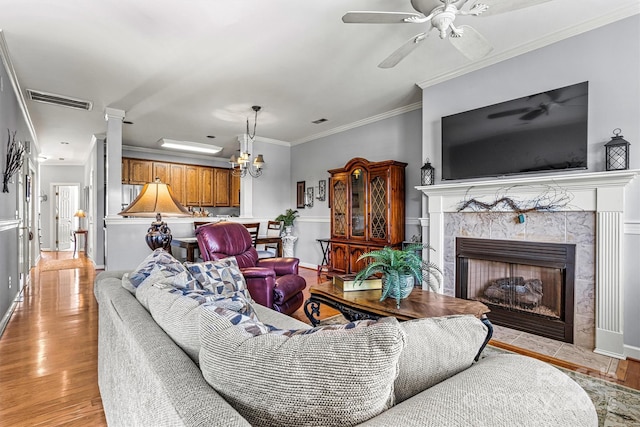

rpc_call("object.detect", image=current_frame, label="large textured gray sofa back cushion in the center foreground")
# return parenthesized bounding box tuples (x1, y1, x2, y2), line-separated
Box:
(200, 307, 405, 426)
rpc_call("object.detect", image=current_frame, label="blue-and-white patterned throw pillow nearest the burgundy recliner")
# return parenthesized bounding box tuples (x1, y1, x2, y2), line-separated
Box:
(185, 257, 251, 300)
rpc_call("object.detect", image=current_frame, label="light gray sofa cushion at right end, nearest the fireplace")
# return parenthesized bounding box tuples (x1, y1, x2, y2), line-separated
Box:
(394, 315, 487, 403)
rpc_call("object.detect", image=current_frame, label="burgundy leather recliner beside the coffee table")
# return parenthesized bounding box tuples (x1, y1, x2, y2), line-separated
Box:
(196, 221, 307, 314)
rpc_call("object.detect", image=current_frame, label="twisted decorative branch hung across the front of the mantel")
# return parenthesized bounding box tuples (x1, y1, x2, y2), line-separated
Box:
(458, 185, 573, 214)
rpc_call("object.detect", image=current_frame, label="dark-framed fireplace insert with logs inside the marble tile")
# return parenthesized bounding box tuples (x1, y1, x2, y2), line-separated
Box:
(455, 237, 576, 343)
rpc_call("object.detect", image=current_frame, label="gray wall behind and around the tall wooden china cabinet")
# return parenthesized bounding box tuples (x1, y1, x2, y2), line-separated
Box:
(289, 110, 424, 265)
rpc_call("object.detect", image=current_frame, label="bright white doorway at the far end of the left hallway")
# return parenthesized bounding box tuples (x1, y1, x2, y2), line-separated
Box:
(51, 183, 80, 251)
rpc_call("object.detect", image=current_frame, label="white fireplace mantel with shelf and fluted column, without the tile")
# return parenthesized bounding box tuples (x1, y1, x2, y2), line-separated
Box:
(416, 170, 640, 359)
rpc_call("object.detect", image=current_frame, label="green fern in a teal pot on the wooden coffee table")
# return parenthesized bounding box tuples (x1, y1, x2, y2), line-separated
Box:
(355, 243, 442, 308)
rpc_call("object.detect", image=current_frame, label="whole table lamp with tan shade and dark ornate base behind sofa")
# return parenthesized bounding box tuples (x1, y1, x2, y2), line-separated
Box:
(118, 178, 191, 251)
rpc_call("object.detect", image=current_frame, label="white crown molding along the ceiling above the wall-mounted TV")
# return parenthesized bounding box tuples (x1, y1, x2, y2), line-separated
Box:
(416, 3, 640, 89)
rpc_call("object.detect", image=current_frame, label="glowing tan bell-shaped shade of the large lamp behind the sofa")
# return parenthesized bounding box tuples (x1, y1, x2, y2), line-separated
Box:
(118, 178, 191, 218)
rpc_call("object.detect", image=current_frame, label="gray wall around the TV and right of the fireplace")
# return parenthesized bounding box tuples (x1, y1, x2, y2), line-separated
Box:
(422, 16, 640, 357)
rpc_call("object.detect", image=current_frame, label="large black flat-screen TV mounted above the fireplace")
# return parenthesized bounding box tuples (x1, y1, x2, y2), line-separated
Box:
(442, 82, 589, 180)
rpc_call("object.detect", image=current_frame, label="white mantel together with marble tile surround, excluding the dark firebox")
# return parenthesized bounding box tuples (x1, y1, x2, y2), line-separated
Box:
(416, 170, 638, 359)
